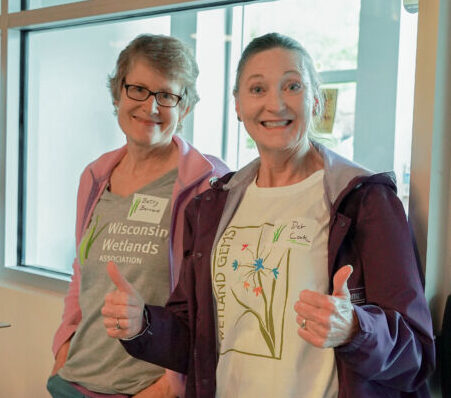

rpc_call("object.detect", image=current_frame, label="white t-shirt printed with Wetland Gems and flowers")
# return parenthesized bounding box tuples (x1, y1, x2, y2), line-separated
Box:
(212, 170, 338, 398)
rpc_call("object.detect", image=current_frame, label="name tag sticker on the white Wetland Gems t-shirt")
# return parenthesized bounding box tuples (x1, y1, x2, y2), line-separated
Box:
(274, 217, 318, 248)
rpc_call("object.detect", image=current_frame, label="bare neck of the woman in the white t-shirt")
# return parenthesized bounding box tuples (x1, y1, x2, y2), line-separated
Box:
(257, 140, 324, 187)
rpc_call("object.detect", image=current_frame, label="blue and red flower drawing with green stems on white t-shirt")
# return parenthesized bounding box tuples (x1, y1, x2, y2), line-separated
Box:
(231, 226, 291, 358)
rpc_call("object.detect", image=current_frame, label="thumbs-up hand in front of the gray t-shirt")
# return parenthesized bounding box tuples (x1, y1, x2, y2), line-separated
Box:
(102, 261, 144, 339)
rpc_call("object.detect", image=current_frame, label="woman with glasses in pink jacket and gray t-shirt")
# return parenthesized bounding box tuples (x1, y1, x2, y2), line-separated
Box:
(48, 35, 227, 397)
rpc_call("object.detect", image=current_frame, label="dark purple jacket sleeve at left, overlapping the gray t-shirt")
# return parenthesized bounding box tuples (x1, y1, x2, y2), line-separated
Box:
(120, 200, 199, 374)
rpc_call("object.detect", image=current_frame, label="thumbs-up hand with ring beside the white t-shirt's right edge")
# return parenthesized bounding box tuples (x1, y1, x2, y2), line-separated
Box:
(294, 265, 359, 348)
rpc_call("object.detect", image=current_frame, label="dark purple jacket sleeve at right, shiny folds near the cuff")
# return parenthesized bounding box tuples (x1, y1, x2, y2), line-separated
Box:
(336, 184, 435, 391)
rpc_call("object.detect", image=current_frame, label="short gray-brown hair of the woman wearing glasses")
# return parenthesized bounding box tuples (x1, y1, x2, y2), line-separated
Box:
(109, 34, 199, 110)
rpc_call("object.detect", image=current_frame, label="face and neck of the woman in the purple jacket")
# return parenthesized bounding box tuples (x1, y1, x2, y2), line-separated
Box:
(235, 42, 323, 186)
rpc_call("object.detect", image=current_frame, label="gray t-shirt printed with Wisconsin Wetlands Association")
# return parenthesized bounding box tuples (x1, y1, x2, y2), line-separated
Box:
(59, 169, 177, 394)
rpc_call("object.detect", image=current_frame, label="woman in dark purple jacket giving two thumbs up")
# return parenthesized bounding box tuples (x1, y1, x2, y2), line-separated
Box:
(102, 33, 434, 398)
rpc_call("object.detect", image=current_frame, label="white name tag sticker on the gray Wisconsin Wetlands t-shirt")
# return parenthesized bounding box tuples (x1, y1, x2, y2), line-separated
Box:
(127, 193, 169, 224)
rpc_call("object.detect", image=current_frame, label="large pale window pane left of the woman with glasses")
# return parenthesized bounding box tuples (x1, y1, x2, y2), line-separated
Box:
(23, 17, 170, 271)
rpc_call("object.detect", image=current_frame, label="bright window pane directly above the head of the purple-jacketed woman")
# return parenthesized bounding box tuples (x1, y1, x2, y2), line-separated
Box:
(244, 0, 360, 71)
